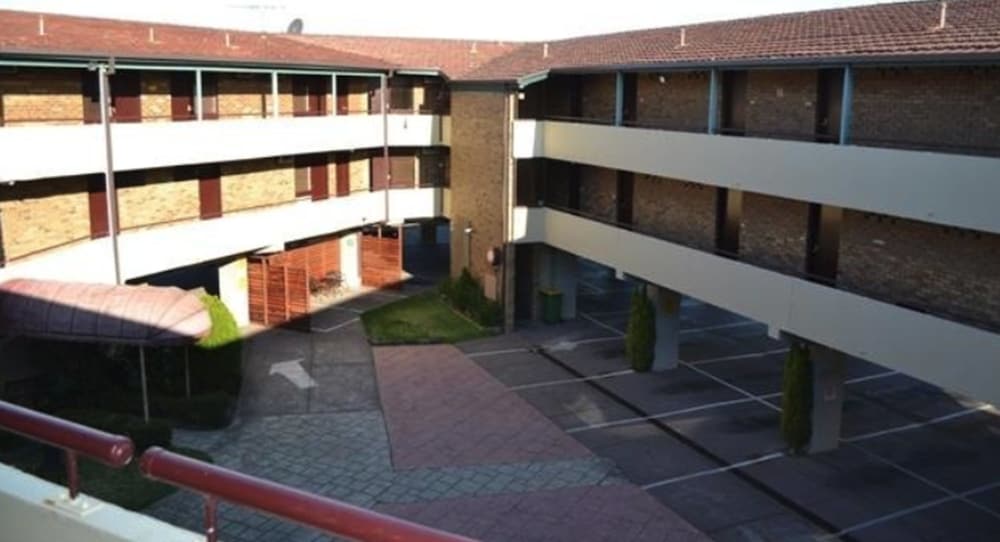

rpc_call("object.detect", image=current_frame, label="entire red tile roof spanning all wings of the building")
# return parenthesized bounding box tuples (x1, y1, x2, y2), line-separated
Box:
(0, 0, 1000, 81)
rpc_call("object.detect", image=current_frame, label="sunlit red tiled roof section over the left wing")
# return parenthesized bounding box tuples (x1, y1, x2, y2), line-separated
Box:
(0, 10, 391, 69)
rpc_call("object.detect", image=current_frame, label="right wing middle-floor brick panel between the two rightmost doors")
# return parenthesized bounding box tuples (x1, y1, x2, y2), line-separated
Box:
(740, 192, 809, 274)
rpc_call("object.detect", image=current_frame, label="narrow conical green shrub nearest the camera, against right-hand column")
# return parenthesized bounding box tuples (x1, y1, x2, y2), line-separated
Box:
(781, 344, 813, 453)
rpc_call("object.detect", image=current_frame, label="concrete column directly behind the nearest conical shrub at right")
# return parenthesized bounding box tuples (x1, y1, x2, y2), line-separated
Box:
(809, 344, 846, 453)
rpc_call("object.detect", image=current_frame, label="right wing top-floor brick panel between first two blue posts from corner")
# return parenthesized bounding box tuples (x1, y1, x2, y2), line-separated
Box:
(636, 72, 709, 132)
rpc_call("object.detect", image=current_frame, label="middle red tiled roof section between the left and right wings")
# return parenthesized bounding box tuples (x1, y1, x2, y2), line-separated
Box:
(293, 35, 522, 79)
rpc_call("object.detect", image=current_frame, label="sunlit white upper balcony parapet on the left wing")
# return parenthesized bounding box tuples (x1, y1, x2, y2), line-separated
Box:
(0, 114, 451, 182)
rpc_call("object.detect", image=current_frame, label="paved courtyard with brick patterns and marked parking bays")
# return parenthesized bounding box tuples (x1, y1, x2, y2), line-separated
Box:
(149, 244, 1000, 541)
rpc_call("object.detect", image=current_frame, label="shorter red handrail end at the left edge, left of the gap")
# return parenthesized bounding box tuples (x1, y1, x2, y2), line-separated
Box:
(0, 401, 135, 499)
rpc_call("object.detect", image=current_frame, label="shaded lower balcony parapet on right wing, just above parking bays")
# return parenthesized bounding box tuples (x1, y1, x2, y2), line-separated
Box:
(514, 207, 1000, 403)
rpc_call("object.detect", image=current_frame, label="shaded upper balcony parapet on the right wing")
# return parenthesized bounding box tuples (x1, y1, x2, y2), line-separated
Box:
(514, 120, 1000, 233)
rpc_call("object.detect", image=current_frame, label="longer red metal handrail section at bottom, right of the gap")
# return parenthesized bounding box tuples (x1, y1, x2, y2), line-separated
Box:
(139, 447, 471, 542)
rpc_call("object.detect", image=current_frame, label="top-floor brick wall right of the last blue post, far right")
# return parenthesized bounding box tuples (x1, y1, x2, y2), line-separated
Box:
(851, 68, 1000, 154)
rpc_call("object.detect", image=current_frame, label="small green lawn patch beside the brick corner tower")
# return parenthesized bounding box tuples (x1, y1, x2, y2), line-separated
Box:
(361, 292, 489, 344)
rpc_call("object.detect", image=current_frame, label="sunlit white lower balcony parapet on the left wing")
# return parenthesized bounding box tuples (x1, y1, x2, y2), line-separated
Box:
(0, 188, 447, 283)
